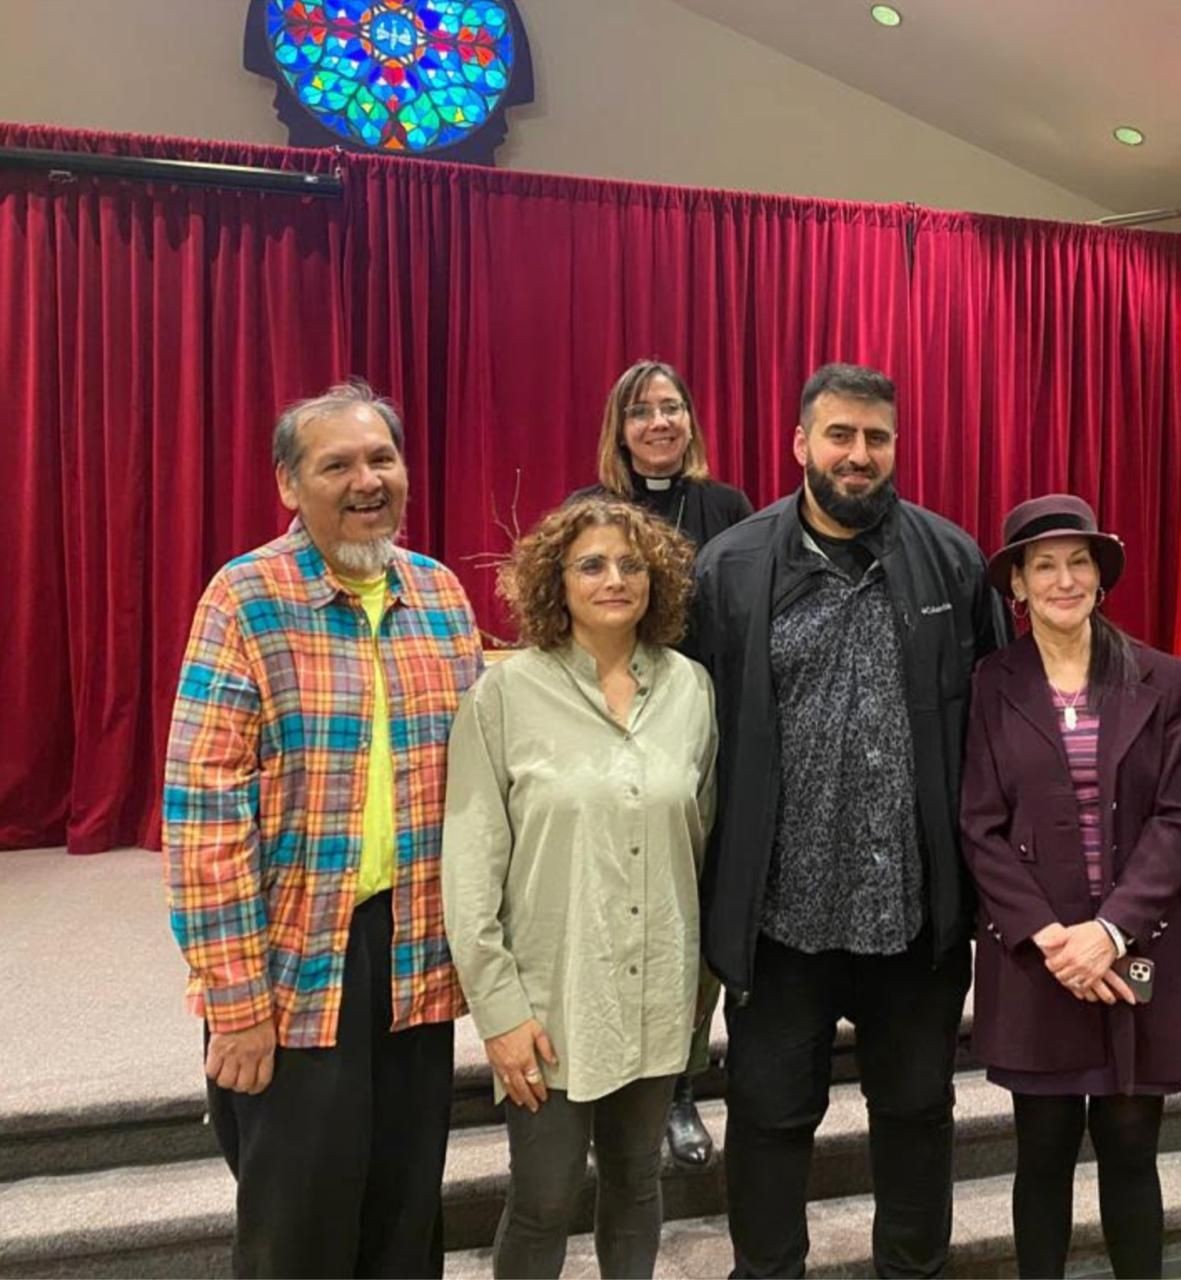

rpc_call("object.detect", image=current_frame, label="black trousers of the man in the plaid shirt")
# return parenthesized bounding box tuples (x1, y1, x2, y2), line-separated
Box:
(209, 892, 454, 1276)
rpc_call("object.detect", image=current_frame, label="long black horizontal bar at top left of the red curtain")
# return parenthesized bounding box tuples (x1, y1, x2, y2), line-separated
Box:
(0, 147, 344, 196)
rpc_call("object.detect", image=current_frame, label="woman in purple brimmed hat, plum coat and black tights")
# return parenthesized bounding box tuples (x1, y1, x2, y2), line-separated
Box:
(961, 494, 1181, 1276)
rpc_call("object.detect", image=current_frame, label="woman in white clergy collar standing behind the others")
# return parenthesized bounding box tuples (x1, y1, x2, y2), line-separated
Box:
(568, 360, 752, 1166)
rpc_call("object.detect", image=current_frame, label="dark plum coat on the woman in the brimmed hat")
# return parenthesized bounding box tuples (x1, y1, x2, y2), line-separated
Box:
(961, 636, 1181, 1082)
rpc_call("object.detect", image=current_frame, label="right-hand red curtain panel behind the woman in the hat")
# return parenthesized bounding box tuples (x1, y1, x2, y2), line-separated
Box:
(900, 210, 1181, 649)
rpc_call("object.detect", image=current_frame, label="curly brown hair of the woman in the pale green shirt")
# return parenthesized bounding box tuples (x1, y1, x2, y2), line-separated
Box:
(496, 498, 694, 649)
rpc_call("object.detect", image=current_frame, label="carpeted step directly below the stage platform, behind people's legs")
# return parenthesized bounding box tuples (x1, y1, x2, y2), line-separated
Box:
(0, 1073, 1156, 1276)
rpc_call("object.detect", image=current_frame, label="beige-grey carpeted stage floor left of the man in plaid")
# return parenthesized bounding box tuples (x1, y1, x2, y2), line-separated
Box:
(0, 849, 202, 1130)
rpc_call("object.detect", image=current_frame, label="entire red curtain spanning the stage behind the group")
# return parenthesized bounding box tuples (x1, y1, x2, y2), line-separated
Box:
(0, 125, 1181, 852)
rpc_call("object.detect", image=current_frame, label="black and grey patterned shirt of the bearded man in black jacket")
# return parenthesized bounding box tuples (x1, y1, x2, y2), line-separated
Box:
(761, 540, 923, 955)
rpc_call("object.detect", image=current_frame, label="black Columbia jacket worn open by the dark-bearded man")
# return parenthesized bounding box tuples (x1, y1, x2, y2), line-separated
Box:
(687, 492, 1007, 1000)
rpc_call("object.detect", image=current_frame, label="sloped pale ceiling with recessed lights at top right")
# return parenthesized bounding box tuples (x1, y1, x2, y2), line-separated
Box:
(679, 0, 1181, 227)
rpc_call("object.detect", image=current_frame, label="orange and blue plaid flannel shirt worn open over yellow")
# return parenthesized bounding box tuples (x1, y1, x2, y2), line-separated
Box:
(164, 520, 482, 1048)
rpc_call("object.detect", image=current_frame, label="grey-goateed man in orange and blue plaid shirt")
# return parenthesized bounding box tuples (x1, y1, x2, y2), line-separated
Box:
(164, 384, 481, 1276)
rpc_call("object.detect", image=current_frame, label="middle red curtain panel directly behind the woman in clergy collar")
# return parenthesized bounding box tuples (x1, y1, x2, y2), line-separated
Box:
(348, 160, 907, 635)
